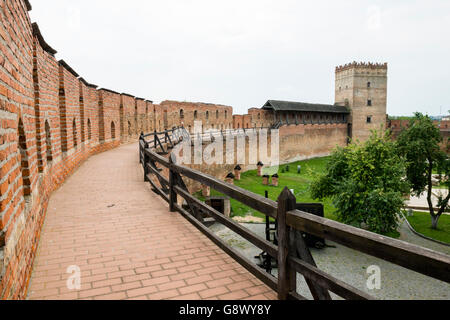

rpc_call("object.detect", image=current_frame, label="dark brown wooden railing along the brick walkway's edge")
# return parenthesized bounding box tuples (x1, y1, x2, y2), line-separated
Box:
(139, 128, 450, 300)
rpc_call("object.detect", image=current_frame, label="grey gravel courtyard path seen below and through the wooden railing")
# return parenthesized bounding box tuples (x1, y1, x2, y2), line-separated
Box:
(211, 218, 450, 300)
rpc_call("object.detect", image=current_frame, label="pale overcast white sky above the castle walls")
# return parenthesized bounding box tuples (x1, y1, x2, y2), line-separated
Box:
(30, 0, 450, 116)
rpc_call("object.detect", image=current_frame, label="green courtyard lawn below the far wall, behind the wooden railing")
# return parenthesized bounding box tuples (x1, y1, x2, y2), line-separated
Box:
(197, 157, 336, 220)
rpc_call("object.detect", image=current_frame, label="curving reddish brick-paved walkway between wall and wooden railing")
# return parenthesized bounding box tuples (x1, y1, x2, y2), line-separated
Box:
(28, 144, 276, 300)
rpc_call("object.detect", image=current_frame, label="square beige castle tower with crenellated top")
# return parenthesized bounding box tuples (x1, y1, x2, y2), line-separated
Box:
(335, 62, 388, 141)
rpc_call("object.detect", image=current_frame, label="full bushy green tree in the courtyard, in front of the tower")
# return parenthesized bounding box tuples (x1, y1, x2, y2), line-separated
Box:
(311, 131, 408, 234)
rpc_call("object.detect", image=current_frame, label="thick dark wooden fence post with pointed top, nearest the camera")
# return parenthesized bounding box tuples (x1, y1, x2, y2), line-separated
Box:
(277, 187, 297, 300)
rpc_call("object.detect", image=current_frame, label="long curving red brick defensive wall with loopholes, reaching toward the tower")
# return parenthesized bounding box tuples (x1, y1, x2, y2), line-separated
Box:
(0, 0, 382, 299)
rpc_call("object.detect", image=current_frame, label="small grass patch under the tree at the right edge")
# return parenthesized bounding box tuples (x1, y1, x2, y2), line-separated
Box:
(405, 211, 450, 243)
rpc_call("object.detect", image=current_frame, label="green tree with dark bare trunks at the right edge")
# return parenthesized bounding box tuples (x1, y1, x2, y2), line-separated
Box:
(397, 113, 450, 229)
